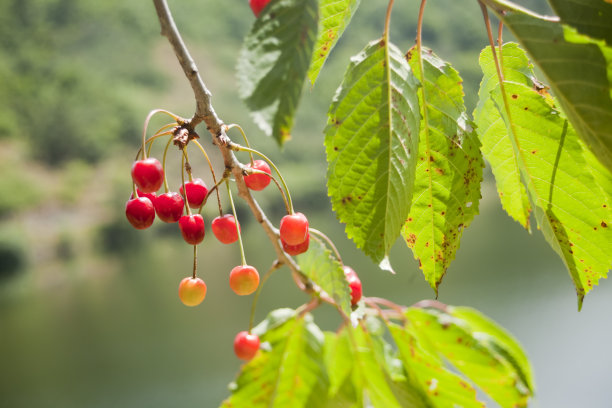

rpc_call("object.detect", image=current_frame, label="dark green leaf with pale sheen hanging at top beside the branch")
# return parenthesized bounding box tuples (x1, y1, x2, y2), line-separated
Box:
(238, 0, 318, 146)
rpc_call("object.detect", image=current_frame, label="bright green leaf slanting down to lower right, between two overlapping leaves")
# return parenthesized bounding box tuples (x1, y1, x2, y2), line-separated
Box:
(406, 308, 532, 408)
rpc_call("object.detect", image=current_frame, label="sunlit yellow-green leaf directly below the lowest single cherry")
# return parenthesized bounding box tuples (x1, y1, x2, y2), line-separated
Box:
(222, 312, 327, 408)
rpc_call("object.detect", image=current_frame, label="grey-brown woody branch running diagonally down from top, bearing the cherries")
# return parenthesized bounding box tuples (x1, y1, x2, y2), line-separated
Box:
(153, 0, 319, 300)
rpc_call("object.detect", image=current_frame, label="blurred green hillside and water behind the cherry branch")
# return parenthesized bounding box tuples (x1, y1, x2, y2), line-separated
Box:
(0, 0, 612, 408)
